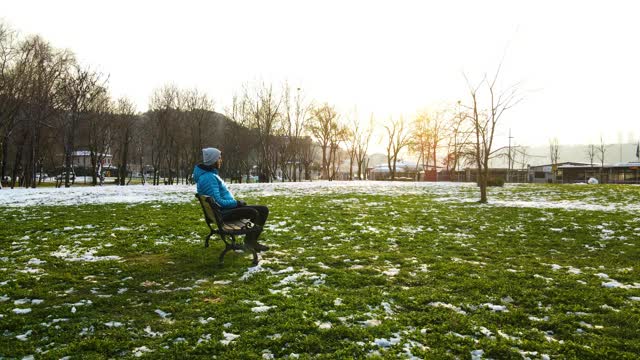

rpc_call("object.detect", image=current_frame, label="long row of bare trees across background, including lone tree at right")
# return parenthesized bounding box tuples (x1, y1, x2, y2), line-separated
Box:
(0, 24, 519, 201)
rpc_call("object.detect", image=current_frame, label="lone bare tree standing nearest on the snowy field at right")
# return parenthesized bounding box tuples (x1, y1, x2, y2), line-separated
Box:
(465, 66, 522, 203)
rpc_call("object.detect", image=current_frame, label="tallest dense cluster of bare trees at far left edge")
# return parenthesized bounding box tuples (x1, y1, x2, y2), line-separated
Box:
(0, 24, 108, 187)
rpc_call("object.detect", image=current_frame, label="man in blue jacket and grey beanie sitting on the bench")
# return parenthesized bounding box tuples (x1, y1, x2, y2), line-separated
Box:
(193, 148, 269, 252)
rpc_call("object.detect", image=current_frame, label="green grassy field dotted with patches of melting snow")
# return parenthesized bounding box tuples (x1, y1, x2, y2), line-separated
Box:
(0, 184, 640, 359)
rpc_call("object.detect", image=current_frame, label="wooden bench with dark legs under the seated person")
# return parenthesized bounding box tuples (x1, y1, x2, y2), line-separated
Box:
(196, 194, 262, 265)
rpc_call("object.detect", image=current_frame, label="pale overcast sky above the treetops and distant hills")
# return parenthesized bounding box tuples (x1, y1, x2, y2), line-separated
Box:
(0, 0, 640, 149)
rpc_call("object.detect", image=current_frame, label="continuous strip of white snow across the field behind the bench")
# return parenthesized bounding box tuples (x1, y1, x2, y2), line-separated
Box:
(0, 181, 640, 212)
